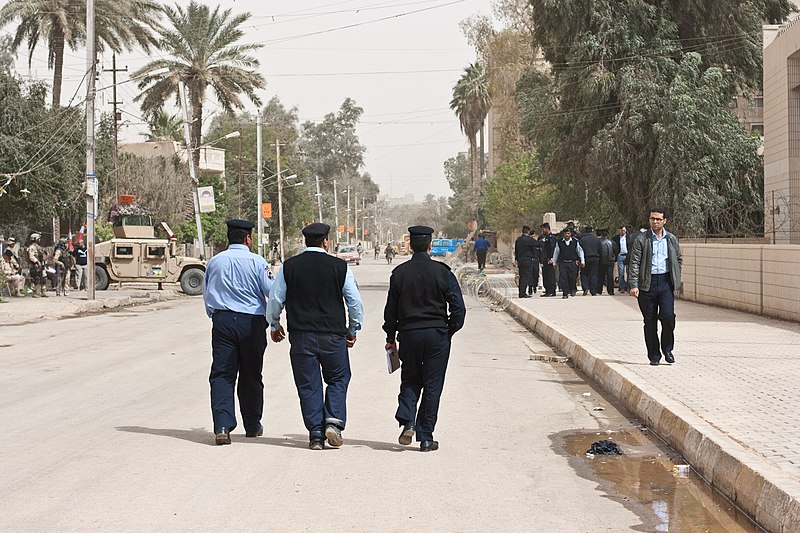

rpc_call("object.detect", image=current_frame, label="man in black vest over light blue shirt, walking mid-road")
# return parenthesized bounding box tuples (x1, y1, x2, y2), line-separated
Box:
(267, 222, 364, 450)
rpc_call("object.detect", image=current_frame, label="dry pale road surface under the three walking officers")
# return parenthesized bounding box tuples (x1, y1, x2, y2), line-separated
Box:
(0, 260, 640, 532)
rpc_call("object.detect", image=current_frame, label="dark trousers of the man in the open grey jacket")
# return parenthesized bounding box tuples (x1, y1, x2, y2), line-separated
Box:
(638, 273, 675, 361)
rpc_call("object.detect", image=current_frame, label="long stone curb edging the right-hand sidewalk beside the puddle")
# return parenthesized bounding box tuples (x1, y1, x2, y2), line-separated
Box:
(506, 301, 800, 533)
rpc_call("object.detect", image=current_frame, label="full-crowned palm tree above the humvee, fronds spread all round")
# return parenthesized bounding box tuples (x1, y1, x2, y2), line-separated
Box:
(132, 0, 266, 163)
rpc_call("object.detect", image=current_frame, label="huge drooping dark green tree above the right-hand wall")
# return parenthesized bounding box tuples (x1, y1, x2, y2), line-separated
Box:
(517, 0, 791, 233)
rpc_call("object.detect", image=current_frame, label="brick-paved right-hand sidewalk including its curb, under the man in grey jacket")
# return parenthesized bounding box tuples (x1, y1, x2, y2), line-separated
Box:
(502, 275, 800, 532)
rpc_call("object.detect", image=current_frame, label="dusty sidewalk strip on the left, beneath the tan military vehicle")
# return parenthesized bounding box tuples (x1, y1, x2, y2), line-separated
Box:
(0, 284, 183, 327)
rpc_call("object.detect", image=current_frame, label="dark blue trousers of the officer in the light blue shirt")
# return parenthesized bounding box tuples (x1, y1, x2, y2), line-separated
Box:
(208, 311, 267, 433)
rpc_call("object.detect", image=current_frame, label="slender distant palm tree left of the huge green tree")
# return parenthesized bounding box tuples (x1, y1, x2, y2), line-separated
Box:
(450, 61, 490, 194)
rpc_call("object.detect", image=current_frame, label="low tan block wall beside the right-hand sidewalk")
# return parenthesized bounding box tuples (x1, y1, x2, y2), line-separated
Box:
(681, 243, 800, 321)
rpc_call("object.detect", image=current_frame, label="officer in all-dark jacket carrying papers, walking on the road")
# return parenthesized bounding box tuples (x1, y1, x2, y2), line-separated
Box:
(383, 226, 467, 452)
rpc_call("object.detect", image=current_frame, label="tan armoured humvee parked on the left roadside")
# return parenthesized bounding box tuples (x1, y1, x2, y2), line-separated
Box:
(94, 214, 206, 296)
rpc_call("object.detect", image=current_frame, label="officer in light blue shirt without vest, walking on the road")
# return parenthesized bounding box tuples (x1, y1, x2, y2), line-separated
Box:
(203, 220, 273, 445)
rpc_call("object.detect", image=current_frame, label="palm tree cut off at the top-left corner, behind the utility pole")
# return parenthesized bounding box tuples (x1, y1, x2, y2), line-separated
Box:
(0, 0, 160, 107)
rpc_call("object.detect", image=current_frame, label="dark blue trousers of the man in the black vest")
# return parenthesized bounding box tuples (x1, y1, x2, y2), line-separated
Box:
(289, 331, 350, 437)
